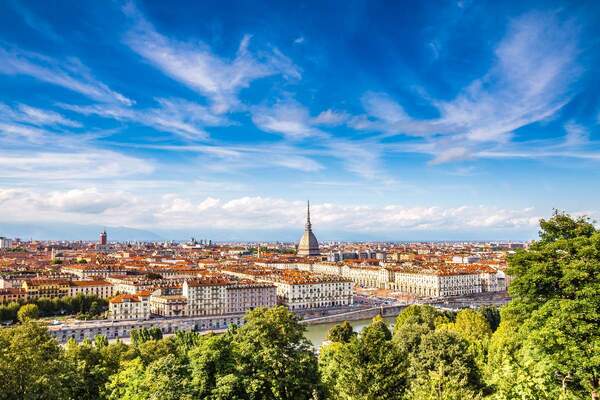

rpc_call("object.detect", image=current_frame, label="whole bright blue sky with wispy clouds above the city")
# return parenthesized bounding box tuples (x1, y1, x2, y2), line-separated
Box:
(0, 1, 600, 240)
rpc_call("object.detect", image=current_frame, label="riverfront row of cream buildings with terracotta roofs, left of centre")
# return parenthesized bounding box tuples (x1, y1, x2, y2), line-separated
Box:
(109, 265, 353, 320)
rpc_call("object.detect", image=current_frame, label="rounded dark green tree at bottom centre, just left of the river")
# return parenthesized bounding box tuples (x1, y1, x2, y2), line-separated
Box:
(232, 306, 322, 400)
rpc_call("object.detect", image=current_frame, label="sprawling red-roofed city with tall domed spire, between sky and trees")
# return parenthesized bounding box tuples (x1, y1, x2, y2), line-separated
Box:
(0, 204, 510, 343)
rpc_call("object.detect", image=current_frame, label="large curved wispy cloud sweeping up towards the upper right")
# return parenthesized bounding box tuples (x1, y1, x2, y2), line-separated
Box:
(349, 12, 581, 163)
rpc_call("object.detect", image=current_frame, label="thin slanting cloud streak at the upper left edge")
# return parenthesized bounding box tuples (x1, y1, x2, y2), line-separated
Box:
(0, 48, 133, 105)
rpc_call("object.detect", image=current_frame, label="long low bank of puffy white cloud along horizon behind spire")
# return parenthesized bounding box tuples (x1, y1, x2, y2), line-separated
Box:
(0, 191, 539, 236)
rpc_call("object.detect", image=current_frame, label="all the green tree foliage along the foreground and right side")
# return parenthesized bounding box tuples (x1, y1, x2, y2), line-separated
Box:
(0, 212, 600, 400)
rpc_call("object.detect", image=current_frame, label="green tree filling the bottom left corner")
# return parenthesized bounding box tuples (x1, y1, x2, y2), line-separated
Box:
(0, 321, 76, 400)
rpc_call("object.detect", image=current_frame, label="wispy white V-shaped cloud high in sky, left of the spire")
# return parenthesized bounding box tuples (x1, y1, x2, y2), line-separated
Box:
(124, 3, 300, 113)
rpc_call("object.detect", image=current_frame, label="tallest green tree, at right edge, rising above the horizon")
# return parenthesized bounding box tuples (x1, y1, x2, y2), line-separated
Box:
(490, 211, 600, 399)
